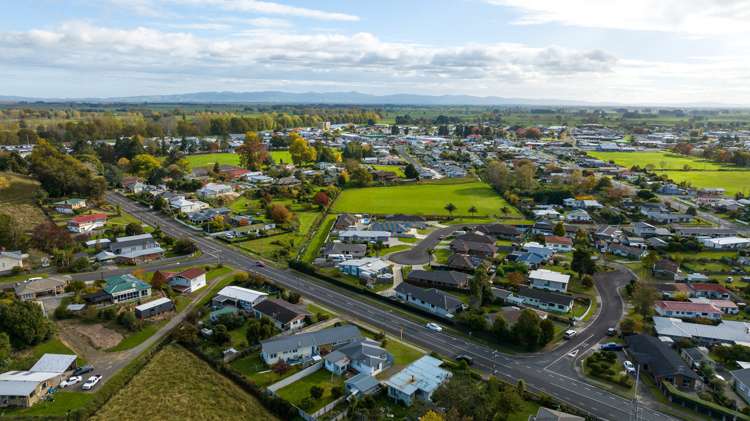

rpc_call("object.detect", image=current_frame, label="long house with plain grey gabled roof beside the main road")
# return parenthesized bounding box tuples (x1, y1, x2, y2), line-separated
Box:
(260, 325, 362, 366)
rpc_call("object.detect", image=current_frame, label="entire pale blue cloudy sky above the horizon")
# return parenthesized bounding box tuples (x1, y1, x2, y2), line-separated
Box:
(0, 0, 750, 105)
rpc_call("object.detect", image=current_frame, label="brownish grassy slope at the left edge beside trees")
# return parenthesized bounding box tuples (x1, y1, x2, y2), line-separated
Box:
(0, 172, 47, 230)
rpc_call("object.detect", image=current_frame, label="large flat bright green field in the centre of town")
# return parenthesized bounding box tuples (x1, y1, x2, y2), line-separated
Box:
(333, 180, 518, 217)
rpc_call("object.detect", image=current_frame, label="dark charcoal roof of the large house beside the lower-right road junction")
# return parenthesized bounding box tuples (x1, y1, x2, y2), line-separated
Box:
(625, 335, 698, 379)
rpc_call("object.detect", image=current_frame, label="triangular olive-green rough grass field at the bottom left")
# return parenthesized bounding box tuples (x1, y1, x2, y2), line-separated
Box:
(92, 346, 277, 421)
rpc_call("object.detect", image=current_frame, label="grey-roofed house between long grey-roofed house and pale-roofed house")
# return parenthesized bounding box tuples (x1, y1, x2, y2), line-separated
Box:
(323, 338, 393, 376)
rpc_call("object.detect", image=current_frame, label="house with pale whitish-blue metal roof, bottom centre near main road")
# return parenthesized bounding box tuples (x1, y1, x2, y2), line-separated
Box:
(385, 355, 452, 406)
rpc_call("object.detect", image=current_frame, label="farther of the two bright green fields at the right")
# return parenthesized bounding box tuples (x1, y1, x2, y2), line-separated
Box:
(589, 152, 732, 170)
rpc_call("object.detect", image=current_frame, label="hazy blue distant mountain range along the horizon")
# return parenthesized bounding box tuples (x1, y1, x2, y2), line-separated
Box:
(0, 91, 732, 107)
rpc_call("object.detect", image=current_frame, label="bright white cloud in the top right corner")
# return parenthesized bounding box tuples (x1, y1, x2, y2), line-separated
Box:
(485, 0, 750, 36)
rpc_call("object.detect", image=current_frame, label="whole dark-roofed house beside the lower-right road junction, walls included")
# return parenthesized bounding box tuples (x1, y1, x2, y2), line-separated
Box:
(625, 334, 699, 390)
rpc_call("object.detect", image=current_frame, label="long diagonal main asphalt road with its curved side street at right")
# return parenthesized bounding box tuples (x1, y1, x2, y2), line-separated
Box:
(107, 193, 673, 421)
